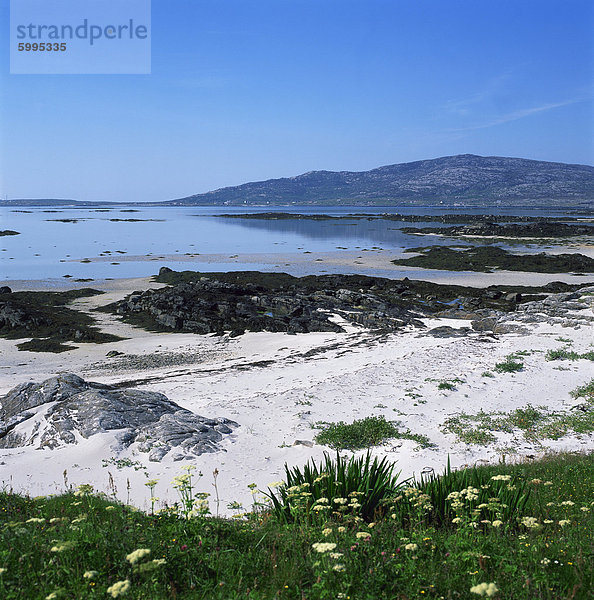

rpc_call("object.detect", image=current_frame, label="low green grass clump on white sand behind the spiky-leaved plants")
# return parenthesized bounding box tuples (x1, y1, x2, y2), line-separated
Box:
(315, 416, 433, 451)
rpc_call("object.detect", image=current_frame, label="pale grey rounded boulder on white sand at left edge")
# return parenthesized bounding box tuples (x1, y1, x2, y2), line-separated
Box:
(0, 374, 238, 461)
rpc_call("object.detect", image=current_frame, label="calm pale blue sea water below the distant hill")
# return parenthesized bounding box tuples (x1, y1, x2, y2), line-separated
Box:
(0, 206, 584, 281)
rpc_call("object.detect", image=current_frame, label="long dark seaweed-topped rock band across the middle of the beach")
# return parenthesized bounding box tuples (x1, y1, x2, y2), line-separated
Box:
(102, 267, 578, 335)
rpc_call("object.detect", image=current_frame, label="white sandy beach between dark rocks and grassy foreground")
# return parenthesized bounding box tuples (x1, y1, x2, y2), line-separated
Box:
(0, 274, 594, 513)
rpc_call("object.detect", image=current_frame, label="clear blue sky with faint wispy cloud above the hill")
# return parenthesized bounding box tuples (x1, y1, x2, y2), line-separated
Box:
(0, 0, 594, 201)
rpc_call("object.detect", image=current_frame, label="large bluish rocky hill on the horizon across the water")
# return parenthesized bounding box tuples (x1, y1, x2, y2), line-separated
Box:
(167, 154, 594, 207)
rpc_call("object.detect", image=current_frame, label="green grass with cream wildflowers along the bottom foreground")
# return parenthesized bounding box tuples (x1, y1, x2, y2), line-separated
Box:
(0, 454, 594, 600)
